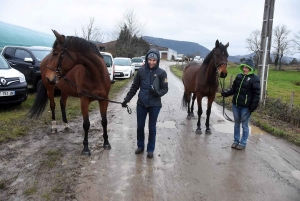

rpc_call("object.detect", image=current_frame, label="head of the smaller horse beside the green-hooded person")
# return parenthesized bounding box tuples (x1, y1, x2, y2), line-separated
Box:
(213, 40, 229, 78)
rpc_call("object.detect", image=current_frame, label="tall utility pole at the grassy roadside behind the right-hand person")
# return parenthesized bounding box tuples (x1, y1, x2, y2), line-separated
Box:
(258, 0, 275, 101)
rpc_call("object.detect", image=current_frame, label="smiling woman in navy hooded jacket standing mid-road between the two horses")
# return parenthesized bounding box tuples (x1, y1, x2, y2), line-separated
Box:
(122, 49, 168, 158)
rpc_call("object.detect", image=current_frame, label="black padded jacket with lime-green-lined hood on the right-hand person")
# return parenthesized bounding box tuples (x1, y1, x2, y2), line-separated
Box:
(222, 59, 260, 111)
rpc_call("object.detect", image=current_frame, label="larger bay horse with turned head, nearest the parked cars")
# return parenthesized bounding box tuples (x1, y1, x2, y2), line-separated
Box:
(28, 30, 111, 156)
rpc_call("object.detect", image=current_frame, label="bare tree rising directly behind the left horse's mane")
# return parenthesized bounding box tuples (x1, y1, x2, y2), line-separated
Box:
(75, 17, 104, 43)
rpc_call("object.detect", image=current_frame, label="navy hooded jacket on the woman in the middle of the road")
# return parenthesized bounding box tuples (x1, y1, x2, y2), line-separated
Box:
(124, 49, 169, 107)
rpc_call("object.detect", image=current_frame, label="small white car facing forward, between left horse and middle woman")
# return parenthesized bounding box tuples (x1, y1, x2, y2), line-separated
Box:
(114, 57, 135, 78)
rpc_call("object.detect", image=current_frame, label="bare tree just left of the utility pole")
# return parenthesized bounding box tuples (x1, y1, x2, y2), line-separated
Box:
(246, 30, 261, 66)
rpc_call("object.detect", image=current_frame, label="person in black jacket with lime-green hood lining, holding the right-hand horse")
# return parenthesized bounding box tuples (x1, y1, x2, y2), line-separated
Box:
(221, 58, 260, 150)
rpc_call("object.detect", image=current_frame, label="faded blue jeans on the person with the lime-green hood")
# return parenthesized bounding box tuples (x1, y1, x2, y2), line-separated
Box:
(232, 104, 251, 146)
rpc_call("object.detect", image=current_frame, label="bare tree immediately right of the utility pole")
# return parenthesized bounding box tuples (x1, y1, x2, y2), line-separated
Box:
(272, 25, 291, 70)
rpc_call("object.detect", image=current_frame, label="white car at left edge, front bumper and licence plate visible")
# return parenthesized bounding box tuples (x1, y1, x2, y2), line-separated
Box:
(0, 55, 28, 104)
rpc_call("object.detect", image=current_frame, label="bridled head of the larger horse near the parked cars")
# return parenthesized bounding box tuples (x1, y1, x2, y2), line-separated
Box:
(47, 30, 78, 84)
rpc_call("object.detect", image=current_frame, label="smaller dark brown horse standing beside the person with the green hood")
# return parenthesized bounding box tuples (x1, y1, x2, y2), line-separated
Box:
(182, 40, 229, 134)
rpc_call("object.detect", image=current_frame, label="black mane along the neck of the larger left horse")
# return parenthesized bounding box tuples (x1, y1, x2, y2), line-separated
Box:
(52, 36, 103, 58)
